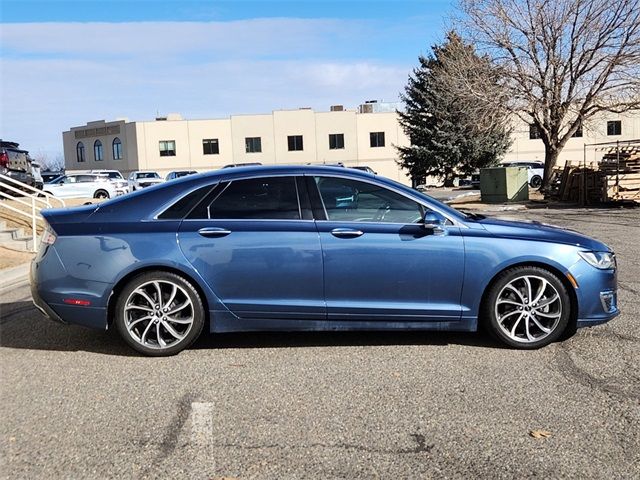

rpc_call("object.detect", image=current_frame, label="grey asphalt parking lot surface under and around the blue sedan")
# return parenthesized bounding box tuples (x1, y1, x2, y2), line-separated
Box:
(0, 209, 640, 479)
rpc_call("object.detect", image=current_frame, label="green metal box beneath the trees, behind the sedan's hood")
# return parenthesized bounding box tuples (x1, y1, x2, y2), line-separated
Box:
(480, 167, 529, 203)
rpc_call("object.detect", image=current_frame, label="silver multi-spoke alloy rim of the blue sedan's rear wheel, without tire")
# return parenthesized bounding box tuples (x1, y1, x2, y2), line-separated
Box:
(124, 280, 194, 350)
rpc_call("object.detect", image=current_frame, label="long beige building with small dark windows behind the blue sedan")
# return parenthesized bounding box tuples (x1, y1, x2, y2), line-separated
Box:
(62, 102, 640, 184)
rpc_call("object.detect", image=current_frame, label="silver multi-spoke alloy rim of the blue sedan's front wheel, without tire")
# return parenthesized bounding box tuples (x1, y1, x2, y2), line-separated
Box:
(495, 275, 562, 344)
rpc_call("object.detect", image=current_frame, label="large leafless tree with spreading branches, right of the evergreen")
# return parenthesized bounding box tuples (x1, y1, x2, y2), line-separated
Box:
(460, 0, 640, 185)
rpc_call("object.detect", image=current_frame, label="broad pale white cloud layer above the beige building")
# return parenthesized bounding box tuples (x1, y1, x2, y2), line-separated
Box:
(0, 19, 420, 154)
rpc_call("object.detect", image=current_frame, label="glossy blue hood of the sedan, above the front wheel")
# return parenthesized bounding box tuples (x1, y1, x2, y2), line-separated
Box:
(477, 218, 611, 252)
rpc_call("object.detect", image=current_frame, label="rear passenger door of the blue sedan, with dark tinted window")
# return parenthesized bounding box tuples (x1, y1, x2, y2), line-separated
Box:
(178, 176, 326, 322)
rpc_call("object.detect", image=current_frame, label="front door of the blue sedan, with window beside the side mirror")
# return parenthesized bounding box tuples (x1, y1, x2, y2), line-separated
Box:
(307, 176, 464, 322)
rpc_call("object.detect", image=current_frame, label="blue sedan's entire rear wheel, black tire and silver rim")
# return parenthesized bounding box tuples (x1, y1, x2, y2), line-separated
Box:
(115, 271, 205, 357)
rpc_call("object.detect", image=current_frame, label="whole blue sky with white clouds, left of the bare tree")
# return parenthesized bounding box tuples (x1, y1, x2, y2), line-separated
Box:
(0, 0, 454, 157)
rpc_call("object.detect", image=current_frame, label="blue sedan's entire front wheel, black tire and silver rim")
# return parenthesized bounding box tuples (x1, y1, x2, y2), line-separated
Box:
(483, 267, 571, 349)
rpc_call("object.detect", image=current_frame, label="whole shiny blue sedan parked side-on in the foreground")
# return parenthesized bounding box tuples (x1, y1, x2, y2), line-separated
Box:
(31, 166, 619, 356)
